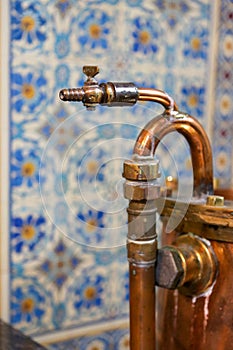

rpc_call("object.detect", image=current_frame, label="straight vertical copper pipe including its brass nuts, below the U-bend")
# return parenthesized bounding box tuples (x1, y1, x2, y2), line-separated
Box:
(123, 159, 160, 350)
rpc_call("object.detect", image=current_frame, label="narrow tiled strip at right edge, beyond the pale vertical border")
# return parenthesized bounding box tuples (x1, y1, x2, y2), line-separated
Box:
(213, 1, 233, 187)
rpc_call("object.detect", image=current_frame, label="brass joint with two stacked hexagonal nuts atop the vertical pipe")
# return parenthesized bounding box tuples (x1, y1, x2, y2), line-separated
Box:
(123, 159, 160, 240)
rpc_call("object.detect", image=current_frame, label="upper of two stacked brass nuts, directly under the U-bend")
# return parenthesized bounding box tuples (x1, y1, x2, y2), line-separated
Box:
(123, 159, 160, 181)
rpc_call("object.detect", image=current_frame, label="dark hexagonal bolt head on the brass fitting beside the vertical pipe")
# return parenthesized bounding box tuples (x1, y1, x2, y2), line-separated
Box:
(155, 246, 185, 289)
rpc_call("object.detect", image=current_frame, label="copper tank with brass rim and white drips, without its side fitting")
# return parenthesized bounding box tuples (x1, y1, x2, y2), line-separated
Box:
(157, 201, 233, 350)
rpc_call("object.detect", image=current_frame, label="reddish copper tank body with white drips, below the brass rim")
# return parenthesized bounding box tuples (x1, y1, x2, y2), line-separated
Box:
(157, 228, 233, 350)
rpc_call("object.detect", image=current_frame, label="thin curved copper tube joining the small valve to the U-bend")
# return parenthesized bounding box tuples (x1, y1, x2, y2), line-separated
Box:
(138, 88, 178, 113)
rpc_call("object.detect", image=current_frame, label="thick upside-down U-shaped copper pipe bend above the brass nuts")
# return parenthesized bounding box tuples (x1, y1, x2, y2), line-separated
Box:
(134, 112, 213, 196)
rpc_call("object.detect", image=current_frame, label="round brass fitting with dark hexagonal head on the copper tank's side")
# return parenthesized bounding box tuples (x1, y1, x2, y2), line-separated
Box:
(155, 233, 218, 296)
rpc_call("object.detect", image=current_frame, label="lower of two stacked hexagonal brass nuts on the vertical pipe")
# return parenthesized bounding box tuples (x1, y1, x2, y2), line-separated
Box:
(124, 181, 160, 201)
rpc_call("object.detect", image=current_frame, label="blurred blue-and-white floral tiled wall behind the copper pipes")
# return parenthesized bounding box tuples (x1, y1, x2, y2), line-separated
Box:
(1, 0, 233, 349)
